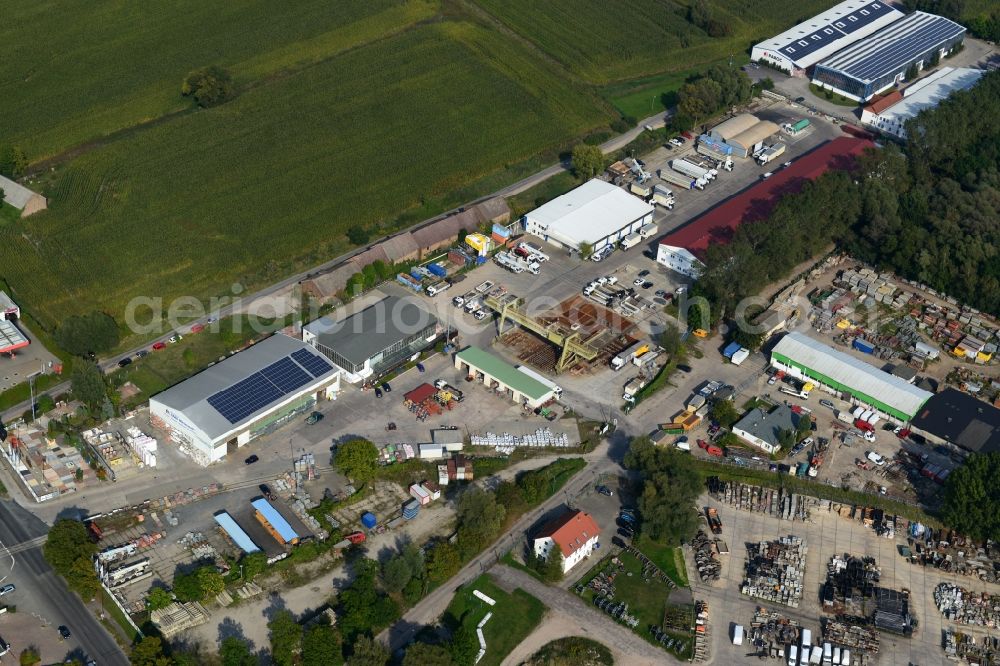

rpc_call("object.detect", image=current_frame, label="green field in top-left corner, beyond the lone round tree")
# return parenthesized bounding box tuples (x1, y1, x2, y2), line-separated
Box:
(0, 0, 438, 161)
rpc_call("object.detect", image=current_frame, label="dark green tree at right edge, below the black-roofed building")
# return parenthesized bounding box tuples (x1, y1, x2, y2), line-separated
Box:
(941, 453, 1000, 541)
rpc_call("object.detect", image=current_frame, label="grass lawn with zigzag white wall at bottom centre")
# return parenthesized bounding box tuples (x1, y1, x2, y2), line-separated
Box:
(445, 574, 545, 666)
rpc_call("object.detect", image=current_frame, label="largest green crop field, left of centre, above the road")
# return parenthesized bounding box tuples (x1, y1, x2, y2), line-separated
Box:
(0, 22, 608, 334)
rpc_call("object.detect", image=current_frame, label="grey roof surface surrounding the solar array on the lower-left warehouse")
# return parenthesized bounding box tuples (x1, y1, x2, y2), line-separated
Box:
(150, 333, 337, 440)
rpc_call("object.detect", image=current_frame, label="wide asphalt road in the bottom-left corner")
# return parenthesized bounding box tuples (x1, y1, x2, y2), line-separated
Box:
(0, 500, 129, 666)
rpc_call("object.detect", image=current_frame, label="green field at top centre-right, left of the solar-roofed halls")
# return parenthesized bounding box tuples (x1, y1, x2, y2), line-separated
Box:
(475, 0, 836, 85)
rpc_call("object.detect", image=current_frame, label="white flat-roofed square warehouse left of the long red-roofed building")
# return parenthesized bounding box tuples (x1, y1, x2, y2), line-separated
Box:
(522, 179, 653, 252)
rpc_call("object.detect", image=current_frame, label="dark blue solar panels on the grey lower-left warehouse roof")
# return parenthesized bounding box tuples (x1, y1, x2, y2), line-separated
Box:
(207, 349, 332, 423)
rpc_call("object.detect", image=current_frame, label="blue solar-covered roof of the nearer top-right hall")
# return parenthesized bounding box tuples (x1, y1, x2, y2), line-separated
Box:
(819, 12, 965, 83)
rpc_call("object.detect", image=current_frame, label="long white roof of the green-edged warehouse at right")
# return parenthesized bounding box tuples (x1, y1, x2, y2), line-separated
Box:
(772, 333, 933, 418)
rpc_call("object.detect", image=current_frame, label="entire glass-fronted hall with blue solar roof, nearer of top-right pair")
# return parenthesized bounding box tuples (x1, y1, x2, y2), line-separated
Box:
(813, 12, 965, 102)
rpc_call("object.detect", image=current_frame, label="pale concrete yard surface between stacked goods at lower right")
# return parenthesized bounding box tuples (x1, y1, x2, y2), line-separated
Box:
(685, 496, 1000, 666)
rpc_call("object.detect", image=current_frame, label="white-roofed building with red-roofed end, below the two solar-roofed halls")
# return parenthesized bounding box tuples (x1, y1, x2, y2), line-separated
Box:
(861, 67, 986, 140)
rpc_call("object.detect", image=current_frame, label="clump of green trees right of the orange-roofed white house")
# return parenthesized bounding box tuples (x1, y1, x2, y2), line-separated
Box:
(625, 437, 702, 545)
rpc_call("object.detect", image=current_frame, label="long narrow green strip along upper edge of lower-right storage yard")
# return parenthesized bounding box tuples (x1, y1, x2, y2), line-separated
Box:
(694, 459, 942, 528)
